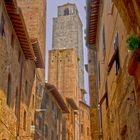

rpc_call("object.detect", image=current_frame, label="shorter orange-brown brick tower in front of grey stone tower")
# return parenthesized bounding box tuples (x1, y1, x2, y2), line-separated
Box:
(48, 48, 79, 103)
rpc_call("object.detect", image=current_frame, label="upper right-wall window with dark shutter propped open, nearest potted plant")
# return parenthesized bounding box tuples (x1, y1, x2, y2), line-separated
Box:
(108, 33, 120, 75)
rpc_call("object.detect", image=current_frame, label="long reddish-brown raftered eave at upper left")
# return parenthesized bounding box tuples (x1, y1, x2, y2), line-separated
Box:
(4, 0, 35, 60)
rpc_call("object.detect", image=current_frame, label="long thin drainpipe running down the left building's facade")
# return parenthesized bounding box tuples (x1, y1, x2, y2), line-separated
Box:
(16, 54, 24, 140)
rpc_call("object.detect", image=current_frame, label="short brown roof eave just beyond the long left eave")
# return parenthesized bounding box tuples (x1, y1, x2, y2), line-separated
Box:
(31, 39, 45, 68)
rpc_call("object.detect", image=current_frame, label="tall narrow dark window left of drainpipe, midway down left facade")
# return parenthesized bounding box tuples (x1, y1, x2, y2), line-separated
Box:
(7, 74, 12, 106)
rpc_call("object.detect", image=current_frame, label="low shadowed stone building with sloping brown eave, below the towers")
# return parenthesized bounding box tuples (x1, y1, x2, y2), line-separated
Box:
(35, 83, 69, 140)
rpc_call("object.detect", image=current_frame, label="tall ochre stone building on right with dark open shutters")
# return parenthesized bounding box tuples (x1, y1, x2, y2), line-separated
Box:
(87, 0, 140, 140)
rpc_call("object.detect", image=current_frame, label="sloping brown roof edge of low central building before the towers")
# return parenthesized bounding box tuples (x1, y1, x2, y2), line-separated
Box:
(45, 83, 69, 113)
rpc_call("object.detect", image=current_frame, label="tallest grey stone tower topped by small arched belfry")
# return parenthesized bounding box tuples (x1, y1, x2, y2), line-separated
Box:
(52, 3, 84, 88)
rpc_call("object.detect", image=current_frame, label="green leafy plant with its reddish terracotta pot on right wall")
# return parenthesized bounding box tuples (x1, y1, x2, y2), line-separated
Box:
(127, 35, 140, 76)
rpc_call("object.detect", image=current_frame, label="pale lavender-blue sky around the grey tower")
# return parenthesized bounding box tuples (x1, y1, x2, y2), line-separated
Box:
(46, 0, 89, 102)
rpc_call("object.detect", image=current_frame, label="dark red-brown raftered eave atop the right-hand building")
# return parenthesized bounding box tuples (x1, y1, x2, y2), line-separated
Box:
(86, 0, 100, 45)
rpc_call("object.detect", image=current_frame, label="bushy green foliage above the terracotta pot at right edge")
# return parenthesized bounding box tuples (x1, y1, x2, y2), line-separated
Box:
(127, 34, 140, 51)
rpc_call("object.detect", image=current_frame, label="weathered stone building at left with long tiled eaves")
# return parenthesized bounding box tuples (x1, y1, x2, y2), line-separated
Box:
(0, 0, 45, 140)
